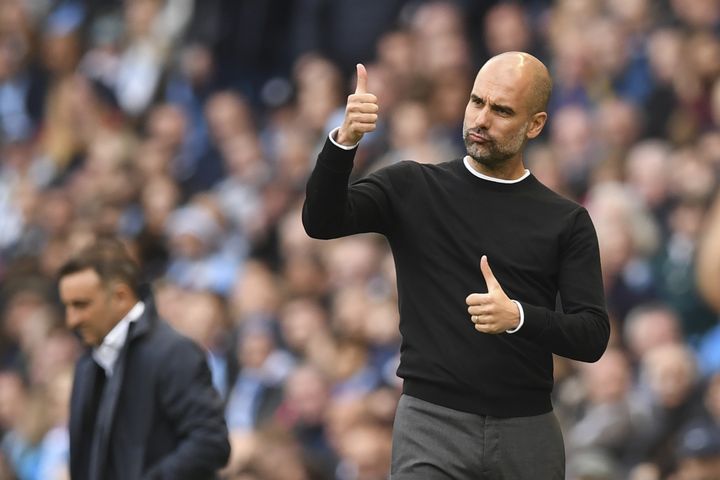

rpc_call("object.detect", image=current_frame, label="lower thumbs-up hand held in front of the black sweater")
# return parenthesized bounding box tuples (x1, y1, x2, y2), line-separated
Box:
(465, 255, 520, 334)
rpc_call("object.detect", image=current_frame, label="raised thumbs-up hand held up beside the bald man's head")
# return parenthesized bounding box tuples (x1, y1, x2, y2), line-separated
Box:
(335, 63, 378, 146)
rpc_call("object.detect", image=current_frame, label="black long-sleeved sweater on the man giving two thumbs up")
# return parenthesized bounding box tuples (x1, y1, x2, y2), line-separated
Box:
(303, 140, 610, 417)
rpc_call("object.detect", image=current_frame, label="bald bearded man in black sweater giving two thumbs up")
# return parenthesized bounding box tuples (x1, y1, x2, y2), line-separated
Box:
(303, 52, 610, 480)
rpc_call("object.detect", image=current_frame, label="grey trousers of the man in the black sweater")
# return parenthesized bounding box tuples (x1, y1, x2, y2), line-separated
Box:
(390, 395, 565, 480)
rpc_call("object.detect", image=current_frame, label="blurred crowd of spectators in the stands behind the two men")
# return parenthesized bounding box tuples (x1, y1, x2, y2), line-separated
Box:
(0, 0, 720, 480)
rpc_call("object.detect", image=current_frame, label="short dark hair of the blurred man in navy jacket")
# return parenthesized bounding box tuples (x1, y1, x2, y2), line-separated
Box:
(58, 238, 140, 296)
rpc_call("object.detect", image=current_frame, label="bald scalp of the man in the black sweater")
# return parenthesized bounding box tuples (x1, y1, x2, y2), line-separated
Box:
(478, 52, 552, 113)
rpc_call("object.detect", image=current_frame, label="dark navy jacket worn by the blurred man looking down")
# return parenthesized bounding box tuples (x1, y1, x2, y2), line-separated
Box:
(70, 301, 230, 480)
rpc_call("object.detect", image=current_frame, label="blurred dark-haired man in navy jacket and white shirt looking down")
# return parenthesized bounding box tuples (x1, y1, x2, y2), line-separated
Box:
(59, 240, 230, 480)
